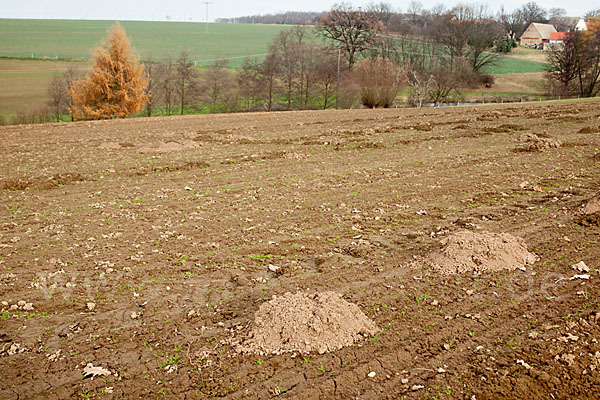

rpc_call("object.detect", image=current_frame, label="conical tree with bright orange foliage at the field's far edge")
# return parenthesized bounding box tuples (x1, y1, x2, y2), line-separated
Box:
(71, 22, 148, 120)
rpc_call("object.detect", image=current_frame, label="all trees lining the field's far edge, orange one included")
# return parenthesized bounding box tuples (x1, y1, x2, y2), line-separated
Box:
(49, 3, 600, 120)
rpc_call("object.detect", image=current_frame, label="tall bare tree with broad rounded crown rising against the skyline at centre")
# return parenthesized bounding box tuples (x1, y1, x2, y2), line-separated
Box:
(317, 3, 377, 69)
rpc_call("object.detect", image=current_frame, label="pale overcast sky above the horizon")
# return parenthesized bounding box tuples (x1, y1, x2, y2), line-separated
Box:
(0, 0, 599, 21)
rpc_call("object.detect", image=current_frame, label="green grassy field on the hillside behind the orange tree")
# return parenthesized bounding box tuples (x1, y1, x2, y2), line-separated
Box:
(0, 19, 290, 66)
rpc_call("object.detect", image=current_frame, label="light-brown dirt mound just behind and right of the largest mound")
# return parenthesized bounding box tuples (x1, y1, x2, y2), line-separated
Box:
(427, 231, 537, 274)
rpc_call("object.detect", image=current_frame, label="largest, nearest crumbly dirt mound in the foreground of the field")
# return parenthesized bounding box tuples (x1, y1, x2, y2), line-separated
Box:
(238, 292, 379, 354)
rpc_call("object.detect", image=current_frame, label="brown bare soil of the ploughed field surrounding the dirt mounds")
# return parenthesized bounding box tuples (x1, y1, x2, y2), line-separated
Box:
(0, 102, 600, 399)
